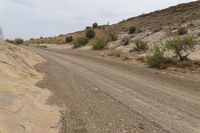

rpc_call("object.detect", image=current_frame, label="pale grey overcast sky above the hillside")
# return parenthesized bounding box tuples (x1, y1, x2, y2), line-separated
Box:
(0, 0, 194, 39)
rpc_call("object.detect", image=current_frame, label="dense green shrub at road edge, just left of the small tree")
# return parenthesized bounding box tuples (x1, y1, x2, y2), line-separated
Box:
(147, 47, 167, 69)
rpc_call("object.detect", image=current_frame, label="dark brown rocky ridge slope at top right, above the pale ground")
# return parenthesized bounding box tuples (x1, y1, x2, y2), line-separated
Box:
(113, 1, 200, 31)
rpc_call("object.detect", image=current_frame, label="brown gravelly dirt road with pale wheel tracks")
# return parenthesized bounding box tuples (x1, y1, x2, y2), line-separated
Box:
(31, 48, 200, 133)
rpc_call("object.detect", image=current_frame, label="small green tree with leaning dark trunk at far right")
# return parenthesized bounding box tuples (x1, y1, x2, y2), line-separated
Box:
(166, 36, 198, 61)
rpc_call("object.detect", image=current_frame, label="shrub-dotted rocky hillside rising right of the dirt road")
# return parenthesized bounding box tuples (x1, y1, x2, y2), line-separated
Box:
(25, 1, 200, 69)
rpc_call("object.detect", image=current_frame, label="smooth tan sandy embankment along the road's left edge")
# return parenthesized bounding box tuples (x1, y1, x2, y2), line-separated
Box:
(0, 41, 60, 133)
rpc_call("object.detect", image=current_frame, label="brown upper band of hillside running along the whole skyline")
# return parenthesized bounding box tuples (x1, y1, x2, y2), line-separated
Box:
(27, 1, 200, 44)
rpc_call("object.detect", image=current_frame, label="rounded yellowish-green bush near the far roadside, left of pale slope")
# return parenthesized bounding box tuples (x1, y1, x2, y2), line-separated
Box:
(91, 37, 109, 50)
